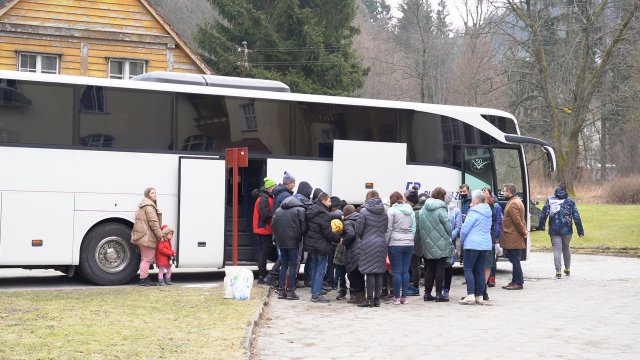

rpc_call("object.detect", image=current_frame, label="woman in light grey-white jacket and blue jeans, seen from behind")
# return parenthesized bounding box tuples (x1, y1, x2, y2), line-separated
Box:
(386, 191, 416, 305)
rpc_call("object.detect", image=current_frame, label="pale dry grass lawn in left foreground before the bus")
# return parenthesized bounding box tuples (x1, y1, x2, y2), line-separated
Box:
(0, 286, 266, 359)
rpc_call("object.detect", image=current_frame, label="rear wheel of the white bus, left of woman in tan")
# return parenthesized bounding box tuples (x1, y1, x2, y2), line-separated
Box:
(80, 223, 140, 285)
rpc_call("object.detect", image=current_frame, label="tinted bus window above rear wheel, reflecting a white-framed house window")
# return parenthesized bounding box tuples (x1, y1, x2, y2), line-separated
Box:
(79, 86, 172, 150)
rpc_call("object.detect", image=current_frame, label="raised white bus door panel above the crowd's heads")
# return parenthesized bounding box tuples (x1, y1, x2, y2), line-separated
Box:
(331, 140, 407, 204)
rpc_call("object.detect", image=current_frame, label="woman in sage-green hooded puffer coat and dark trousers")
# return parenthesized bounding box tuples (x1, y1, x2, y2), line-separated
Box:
(420, 187, 454, 302)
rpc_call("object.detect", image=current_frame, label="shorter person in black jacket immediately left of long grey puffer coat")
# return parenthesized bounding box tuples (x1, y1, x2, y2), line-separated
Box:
(342, 205, 365, 304)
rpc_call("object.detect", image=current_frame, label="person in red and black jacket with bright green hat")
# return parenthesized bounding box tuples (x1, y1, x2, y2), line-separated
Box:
(253, 177, 276, 284)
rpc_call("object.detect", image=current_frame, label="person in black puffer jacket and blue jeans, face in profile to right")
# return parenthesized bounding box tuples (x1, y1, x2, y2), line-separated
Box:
(304, 193, 340, 303)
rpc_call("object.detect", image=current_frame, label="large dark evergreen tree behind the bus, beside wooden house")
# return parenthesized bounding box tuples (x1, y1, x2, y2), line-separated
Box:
(195, 0, 368, 96)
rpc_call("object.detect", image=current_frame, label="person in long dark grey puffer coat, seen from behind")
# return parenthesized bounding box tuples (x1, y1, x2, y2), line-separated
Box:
(356, 190, 389, 307)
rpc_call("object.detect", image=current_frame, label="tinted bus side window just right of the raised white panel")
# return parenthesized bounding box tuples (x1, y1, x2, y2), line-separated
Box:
(408, 112, 462, 168)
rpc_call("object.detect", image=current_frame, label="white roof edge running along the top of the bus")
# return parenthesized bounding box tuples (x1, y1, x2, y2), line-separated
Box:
(0, 70, 519, 143)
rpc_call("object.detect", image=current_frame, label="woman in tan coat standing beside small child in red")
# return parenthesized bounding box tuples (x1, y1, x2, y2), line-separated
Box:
(131, 188, 164, 286)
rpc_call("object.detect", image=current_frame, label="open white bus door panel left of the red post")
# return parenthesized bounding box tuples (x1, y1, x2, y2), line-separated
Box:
(177, 157, 226, 268)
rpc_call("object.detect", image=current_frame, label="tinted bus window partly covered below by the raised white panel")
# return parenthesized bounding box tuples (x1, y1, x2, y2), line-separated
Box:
(294, 103, 398, 158)
